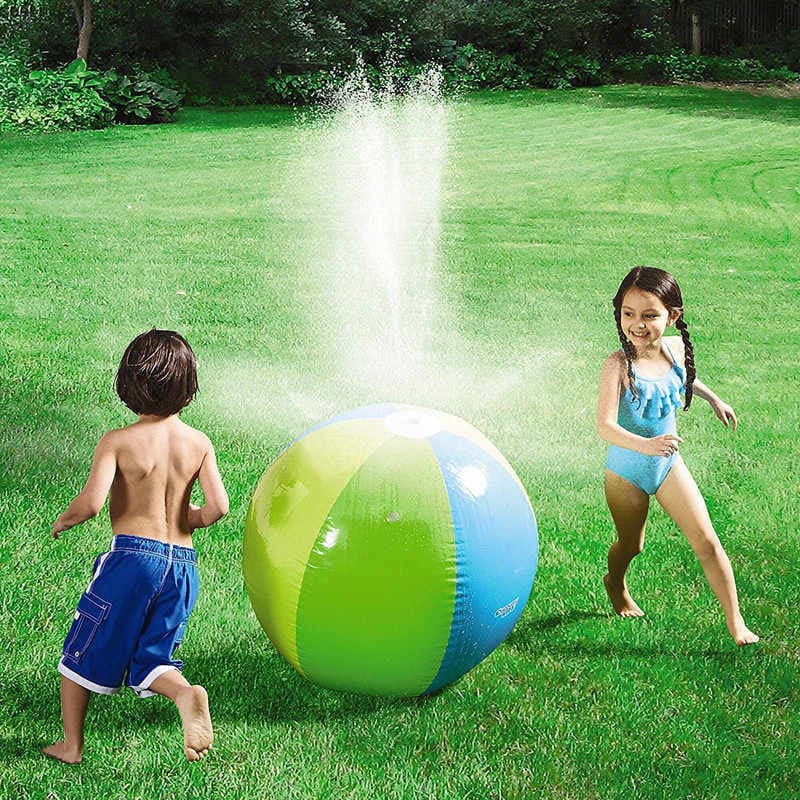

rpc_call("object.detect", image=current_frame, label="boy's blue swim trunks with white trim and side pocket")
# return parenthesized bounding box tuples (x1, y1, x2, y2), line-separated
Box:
(58, 535, 200, 697)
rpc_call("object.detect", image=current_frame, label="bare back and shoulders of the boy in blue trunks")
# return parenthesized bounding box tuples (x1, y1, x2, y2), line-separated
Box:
(107, 416, 217, 547)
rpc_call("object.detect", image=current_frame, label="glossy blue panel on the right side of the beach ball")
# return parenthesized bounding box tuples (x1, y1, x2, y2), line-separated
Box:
(425, 431, 539, 694)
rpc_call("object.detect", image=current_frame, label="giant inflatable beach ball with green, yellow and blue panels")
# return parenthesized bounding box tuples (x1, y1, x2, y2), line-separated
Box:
(243, 404, 538, 695)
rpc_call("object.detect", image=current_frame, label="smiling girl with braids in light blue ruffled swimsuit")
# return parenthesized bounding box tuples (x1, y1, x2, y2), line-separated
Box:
(597, 267, 758, 645)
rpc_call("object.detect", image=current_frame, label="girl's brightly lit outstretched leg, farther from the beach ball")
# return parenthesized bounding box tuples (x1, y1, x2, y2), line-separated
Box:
(656, 457, 758, 644)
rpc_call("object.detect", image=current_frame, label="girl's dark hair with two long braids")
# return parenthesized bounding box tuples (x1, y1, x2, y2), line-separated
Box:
(614, 267, 696, 409)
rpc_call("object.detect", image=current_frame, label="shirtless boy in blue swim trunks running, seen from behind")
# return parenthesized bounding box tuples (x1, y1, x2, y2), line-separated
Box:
(42, 328, 228, 764)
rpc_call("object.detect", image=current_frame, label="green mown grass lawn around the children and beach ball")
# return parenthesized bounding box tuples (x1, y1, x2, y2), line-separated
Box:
(0, 86, 800, 800)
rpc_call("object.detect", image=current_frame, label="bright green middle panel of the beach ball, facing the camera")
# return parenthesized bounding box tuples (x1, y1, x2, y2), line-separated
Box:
(297, 432, 456, 695)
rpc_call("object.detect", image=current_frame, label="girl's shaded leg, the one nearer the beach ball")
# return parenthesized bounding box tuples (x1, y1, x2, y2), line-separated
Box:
(603, 470, 650, 617)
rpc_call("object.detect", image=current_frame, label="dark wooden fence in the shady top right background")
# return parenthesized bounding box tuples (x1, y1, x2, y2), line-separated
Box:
(672, 0, 800, 54)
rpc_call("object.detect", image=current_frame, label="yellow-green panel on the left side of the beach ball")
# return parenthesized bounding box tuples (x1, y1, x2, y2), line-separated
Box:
(243, 420, 391, 672)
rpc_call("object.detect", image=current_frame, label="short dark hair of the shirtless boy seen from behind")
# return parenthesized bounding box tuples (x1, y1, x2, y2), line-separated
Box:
(115, 328, 197, 417)
